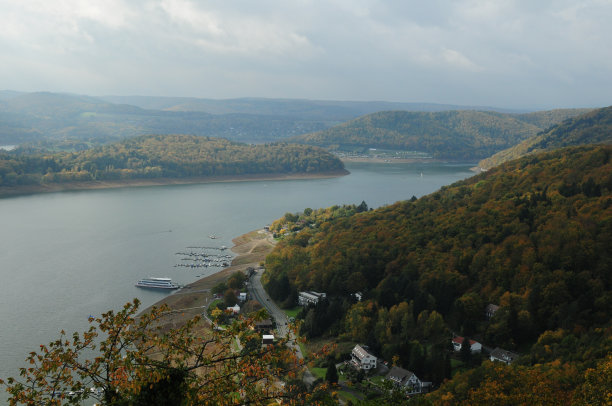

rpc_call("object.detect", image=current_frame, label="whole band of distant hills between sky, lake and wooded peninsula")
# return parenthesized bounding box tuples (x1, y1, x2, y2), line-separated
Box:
(0, 91, 600, 160)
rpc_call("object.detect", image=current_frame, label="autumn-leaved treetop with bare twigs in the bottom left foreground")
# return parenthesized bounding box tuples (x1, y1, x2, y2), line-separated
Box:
(0, 299, 320, 405)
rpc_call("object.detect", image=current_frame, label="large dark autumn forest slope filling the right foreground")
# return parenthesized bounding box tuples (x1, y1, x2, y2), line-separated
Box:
(266, 146, 612, 403)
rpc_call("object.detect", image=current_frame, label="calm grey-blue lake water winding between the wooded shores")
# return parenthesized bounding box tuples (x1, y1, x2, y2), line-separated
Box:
(0, 163, 473, 390)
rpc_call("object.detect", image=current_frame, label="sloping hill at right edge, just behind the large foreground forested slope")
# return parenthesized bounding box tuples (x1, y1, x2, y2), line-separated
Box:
(478, 106, 612, 169)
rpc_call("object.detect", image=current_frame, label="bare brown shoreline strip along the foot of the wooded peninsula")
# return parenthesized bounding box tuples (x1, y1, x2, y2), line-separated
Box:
(0, 169, 350, 198)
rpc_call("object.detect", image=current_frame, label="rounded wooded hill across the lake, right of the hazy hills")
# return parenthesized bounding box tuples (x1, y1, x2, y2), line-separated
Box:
(291, 110, 582, 160)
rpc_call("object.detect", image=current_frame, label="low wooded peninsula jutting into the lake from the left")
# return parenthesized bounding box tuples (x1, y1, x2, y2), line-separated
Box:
(0, 135, 344, 186)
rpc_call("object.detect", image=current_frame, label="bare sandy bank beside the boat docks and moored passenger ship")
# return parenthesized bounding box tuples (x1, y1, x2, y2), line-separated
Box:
(143, 230, 276, 328)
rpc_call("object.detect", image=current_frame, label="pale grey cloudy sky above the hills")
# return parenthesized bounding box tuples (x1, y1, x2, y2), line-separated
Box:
(0, 0, 612, 108)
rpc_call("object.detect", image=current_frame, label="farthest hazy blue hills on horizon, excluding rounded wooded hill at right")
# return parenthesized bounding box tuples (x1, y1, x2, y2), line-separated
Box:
(0, 91, 524, 149)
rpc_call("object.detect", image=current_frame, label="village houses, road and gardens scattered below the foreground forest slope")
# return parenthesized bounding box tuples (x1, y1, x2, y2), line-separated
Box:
(206, 266, 519, 401)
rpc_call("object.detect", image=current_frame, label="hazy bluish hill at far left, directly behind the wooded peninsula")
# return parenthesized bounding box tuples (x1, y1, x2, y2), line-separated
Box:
(0, 93, 336, 145)
